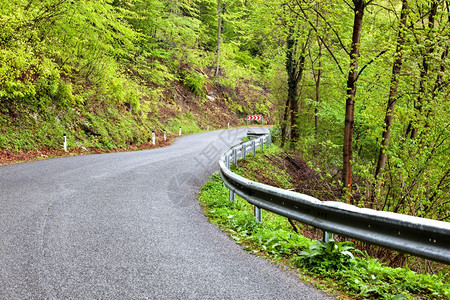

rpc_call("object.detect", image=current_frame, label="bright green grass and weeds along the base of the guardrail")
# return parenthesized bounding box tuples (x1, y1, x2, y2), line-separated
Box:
(199, 146, 450, 300)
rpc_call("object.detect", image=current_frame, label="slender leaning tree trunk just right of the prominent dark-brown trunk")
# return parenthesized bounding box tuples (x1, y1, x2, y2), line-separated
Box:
(372, 0, 409, 180)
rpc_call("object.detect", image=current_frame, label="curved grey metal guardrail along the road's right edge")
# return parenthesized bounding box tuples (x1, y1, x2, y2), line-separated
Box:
(219, 135, 450, 264)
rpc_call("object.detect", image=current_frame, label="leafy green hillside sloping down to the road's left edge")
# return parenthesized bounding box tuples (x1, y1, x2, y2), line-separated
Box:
(0, 1, 273, 155)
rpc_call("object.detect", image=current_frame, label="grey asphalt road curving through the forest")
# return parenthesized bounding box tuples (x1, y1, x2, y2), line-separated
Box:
(0, 129, 330, 299)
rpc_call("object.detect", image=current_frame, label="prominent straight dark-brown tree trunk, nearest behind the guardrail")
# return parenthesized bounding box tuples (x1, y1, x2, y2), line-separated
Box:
(342, 0, 366, 204)
